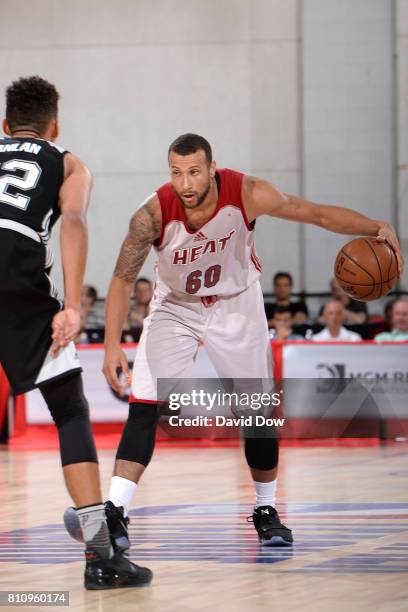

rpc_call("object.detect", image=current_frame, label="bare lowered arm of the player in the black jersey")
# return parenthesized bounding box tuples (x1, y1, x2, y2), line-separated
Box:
(52, 153, 92, 352)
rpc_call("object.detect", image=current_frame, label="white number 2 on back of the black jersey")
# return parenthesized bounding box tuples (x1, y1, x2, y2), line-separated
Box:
(0, 159, 41, 210)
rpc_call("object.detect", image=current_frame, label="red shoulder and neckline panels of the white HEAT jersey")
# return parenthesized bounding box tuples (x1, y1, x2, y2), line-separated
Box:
(153, 168, 255, 247)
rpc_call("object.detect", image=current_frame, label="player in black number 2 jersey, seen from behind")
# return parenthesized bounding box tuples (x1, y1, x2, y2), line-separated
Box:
(0, 77, 152, 589)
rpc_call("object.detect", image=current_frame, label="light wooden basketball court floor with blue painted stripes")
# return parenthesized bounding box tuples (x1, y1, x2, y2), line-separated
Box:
(0, 443, 408, 612)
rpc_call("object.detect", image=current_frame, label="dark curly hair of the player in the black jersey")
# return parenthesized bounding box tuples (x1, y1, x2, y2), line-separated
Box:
(6, 76, 59, 133)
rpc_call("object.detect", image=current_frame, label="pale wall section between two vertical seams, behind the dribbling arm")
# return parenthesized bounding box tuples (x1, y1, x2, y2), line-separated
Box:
(303, 0, 395, 290)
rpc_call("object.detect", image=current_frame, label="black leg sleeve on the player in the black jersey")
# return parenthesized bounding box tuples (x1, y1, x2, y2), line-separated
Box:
(40, 373, 98, 466)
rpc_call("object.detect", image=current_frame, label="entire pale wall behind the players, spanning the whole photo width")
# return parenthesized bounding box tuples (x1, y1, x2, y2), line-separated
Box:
(0, 0, 408, 295)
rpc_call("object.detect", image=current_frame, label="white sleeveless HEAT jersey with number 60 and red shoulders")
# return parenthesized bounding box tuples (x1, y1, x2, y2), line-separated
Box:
(154, 168, 262, 297)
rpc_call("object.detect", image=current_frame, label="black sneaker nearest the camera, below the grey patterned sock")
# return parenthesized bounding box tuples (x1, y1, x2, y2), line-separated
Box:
(84, 551, 153, 591)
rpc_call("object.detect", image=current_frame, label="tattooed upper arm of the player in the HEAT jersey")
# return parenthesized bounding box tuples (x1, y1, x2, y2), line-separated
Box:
(114, 204, 160, 282)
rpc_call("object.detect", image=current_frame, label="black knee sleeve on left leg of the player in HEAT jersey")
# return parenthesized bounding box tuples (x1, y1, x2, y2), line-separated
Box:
(116, 404, 159, 466)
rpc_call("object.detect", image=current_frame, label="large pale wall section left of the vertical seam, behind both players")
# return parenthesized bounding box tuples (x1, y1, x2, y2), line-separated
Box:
(0, 0, 298, 294)
